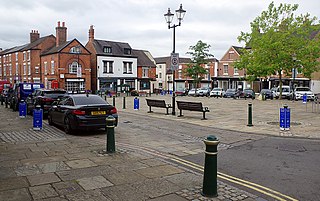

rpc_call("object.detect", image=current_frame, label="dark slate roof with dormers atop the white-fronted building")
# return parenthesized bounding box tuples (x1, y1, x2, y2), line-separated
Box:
(93, 40, 134, 57)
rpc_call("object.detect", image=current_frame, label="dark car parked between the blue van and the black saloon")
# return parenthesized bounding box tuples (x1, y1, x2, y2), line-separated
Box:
(26, 88, 67, 115)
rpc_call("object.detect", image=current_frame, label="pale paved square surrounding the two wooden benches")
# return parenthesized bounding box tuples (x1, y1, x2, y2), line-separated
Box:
(107, 95, 320, 138)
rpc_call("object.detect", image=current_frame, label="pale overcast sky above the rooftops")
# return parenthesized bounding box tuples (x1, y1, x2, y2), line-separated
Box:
(0, 0, 320, 59)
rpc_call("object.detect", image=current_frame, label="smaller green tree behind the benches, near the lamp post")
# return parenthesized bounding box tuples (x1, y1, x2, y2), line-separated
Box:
(184, 40, 213, 87)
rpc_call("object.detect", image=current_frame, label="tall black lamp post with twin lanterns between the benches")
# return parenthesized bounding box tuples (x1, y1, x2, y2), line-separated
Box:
(164, 4, 186, 115)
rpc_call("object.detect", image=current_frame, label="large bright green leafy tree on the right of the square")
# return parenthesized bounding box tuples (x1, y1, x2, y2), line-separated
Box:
(235, 2, 320, 99)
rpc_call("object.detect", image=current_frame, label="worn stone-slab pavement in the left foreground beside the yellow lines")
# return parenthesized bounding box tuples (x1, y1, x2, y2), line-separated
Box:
(0, 106, 263, 201)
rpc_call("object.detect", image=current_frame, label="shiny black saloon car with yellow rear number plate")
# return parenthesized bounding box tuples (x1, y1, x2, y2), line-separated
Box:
(48, 94, 118, 134)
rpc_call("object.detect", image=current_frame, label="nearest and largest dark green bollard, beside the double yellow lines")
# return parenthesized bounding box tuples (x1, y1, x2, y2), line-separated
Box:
(201, 135, 220, 197)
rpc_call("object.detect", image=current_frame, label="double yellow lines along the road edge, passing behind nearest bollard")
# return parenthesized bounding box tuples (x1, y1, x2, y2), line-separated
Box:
(118, 143, 298, 201)
